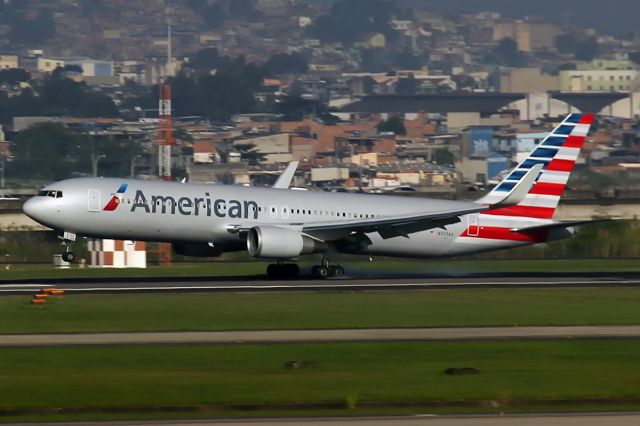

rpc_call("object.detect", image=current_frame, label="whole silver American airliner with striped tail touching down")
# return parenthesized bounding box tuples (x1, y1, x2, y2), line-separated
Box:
(24, 114, 594, 278)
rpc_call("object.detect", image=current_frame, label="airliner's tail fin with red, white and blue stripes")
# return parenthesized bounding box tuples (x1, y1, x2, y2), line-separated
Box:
(478, 114, 595, 220)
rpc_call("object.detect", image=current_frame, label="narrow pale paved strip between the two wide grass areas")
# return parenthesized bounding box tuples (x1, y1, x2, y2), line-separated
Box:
(0, 325, 640, 347)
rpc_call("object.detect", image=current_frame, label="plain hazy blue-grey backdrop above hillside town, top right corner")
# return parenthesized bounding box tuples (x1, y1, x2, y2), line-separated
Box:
(400, 0, 640, 35)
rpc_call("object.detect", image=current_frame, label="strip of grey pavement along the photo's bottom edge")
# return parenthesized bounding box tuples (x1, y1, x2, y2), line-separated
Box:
(7, 413, 640, 426)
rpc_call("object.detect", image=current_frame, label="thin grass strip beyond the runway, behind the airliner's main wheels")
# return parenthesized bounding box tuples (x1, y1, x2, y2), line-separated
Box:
(0, 258, 640, 283)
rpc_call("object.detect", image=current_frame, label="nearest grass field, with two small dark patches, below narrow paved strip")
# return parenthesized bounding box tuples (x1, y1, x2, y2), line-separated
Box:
(0, 340, 640, 420)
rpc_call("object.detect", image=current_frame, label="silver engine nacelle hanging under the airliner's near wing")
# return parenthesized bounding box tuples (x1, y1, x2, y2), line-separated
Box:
(247, 226, 327, 259)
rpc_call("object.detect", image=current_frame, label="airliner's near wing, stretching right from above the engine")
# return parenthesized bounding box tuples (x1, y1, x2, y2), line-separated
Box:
(302, 205, 487, 240)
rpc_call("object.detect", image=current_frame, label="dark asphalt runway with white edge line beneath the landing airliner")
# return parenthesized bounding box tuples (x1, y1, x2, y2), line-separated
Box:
(0, 273, 640, 296)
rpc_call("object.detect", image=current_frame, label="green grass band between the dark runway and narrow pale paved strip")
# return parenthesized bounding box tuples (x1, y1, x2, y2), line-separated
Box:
(0, 288, 640, 333)
